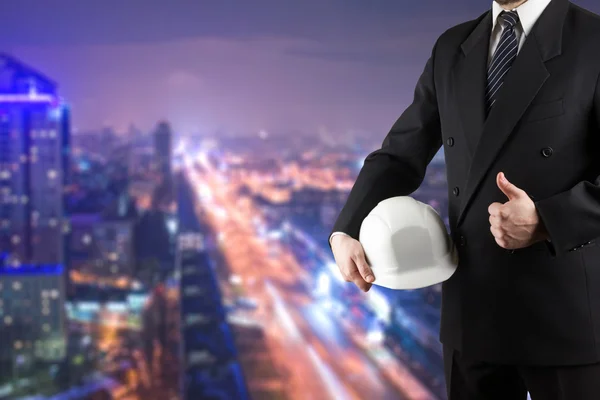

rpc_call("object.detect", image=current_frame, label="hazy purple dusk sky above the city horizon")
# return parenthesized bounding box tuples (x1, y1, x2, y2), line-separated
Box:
(0, 0, 600, 135)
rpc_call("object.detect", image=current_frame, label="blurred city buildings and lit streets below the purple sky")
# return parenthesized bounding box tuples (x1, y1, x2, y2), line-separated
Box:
(0, 54, 447, 400)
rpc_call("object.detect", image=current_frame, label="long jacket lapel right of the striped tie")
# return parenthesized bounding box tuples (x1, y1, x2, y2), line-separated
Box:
(457, 0, 569, 225)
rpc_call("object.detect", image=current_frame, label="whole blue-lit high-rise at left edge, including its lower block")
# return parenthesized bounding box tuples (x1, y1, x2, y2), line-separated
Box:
(0, 54, 70, 392)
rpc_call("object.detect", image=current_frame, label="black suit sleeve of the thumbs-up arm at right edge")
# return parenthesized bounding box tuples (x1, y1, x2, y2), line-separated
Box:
(534, 72, 600, 257)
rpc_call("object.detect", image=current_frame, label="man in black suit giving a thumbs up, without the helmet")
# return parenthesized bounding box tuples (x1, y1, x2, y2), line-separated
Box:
(330, 0, 600, 400)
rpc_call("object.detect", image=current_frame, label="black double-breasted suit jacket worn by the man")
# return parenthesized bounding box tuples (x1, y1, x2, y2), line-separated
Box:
(331, 0, 600, 365)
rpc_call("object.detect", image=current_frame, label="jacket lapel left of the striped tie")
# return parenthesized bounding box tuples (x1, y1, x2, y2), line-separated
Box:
(452, 11, 492, 158)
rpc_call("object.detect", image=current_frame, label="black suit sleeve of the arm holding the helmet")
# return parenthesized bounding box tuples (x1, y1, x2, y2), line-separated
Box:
(330, 39, 442, 250)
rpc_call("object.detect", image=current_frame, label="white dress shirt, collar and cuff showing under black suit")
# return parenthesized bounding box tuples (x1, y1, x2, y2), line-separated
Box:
(329, 0, 552, 247)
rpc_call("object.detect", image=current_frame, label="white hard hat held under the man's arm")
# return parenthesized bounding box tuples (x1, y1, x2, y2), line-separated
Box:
(359, 196, 458, 289)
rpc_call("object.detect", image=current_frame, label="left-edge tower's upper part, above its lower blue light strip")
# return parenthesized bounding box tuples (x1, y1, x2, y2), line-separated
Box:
(0, 55, 70, 266)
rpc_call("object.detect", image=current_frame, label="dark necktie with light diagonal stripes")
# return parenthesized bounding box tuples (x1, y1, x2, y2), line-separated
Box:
(485, 11, 519, 115)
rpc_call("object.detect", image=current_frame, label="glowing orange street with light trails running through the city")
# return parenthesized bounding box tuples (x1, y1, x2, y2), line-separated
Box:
(186, 154, 434, 400)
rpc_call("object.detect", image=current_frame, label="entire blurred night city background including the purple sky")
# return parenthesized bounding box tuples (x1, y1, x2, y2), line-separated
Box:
(0, 0, 600, 400)
